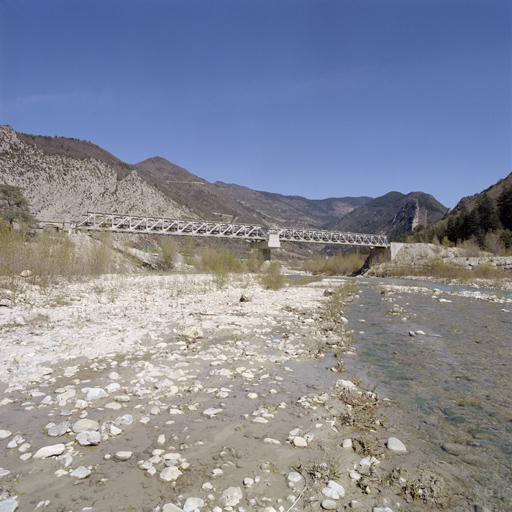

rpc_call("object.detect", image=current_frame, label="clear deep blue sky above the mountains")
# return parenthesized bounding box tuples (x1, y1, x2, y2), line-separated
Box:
(0, 0, 512, 207)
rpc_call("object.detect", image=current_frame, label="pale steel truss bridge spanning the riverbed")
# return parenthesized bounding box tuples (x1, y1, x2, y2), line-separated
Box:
(75, 213, 389, 247)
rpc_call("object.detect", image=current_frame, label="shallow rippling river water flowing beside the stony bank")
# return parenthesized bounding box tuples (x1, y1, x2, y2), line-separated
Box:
(345, 285, 512, 511)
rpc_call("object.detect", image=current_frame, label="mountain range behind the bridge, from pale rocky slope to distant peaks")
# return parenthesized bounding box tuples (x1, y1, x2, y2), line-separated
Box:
(0, 125, 454, 241)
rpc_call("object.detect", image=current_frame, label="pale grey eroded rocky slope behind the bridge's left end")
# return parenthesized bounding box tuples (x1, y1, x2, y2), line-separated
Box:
(0, 126, 195, 220)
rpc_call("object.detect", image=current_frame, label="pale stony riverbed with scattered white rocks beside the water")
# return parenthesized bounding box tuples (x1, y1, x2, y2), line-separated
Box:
(0, 275, 486, 512)
